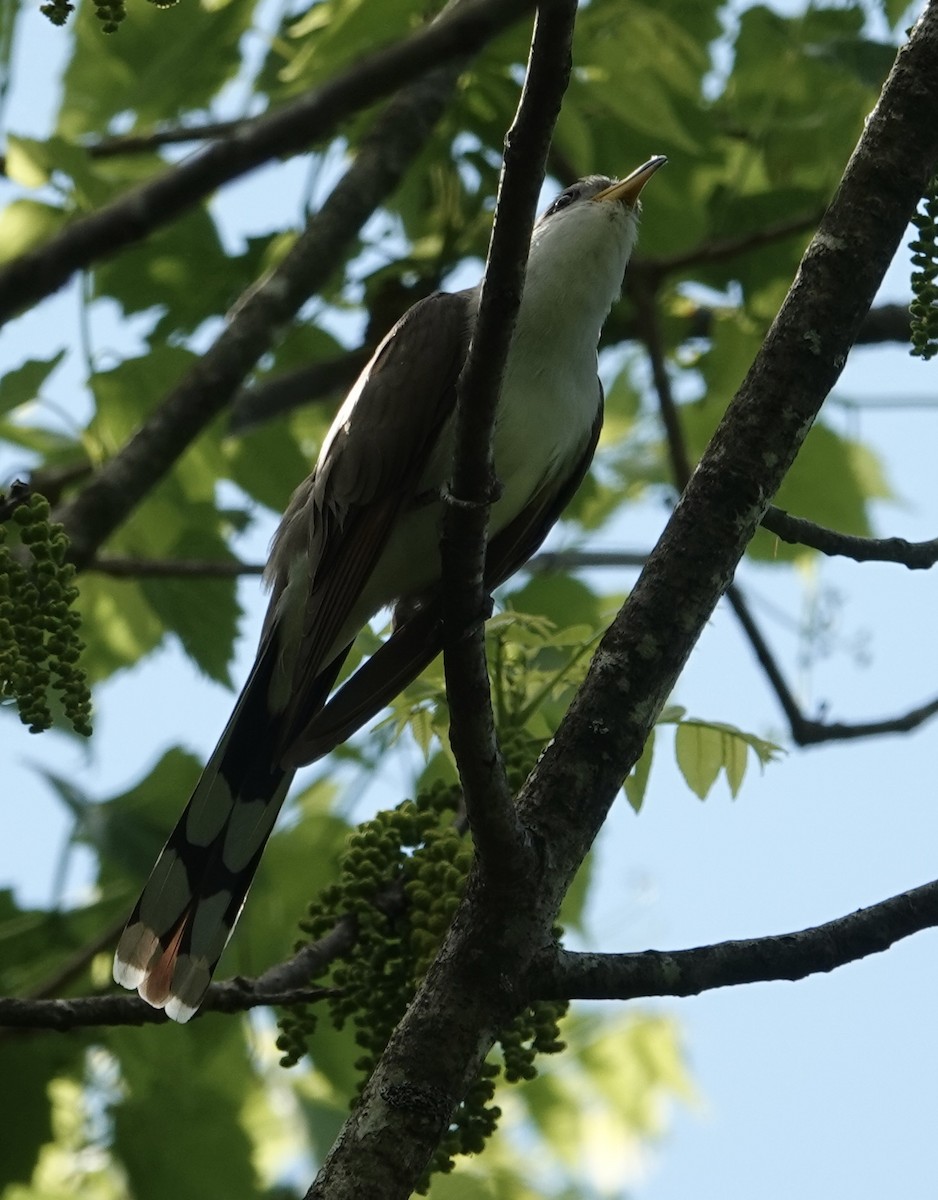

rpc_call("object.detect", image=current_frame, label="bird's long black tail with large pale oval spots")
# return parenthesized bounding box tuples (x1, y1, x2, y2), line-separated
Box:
(114, 649, 344, 1022)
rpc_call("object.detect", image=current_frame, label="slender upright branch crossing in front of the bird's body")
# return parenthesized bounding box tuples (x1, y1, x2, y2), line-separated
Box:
(441, 0, 577, 882)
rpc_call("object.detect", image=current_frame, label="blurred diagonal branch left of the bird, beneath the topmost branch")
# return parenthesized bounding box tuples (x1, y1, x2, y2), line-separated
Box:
(56, 66, 457, 566)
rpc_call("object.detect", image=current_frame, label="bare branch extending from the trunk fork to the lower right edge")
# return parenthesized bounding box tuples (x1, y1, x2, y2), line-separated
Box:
(530, 882, 938, 1000)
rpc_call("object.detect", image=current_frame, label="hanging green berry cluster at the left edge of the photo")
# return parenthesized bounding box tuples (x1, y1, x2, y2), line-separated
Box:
(0, 485, 91, 737)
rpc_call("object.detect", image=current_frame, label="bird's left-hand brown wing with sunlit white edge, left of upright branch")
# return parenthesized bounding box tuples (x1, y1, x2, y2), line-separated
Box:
(265, 293, 470, 749)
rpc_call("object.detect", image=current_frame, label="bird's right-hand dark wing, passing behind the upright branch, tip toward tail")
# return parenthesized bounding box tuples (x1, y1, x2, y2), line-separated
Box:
(289, 388, 603, 767)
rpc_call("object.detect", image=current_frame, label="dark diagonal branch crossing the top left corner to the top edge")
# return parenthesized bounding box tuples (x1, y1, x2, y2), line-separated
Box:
(0, 0, 534, 324)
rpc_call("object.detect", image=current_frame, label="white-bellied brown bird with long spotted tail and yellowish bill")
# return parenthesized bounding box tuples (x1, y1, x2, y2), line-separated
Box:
(114, 155, 667, 1022)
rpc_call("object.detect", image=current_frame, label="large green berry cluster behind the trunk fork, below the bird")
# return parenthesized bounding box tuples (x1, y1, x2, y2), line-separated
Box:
(277, 732, 566, 1192)
